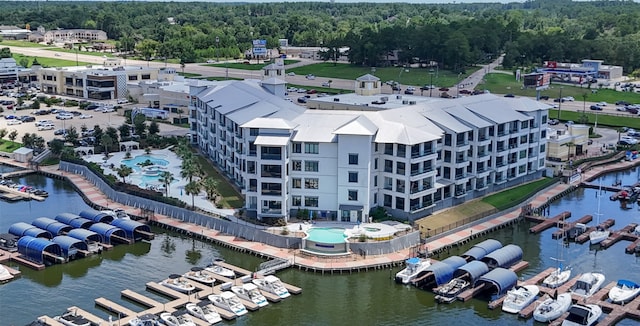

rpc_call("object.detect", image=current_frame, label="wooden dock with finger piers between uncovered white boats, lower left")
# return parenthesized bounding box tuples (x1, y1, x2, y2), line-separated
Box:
(38, 261, 302, 326)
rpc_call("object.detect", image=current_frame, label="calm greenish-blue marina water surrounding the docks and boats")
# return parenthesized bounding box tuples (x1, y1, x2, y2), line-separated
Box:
(0, 167, 640, 325)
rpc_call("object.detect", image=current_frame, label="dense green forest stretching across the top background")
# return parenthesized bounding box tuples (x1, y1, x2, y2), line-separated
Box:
(0, 0, 640, 72)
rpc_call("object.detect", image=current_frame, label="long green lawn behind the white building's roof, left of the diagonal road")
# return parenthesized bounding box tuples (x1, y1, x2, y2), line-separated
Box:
(288, 62, 480, 87)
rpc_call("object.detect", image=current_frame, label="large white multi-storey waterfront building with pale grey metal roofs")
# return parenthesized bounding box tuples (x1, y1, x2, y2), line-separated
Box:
(189, 66, 549, 222)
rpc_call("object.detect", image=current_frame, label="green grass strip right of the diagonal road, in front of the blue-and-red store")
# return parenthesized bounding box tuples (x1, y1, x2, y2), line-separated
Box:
(476, 73, 640, 103)
